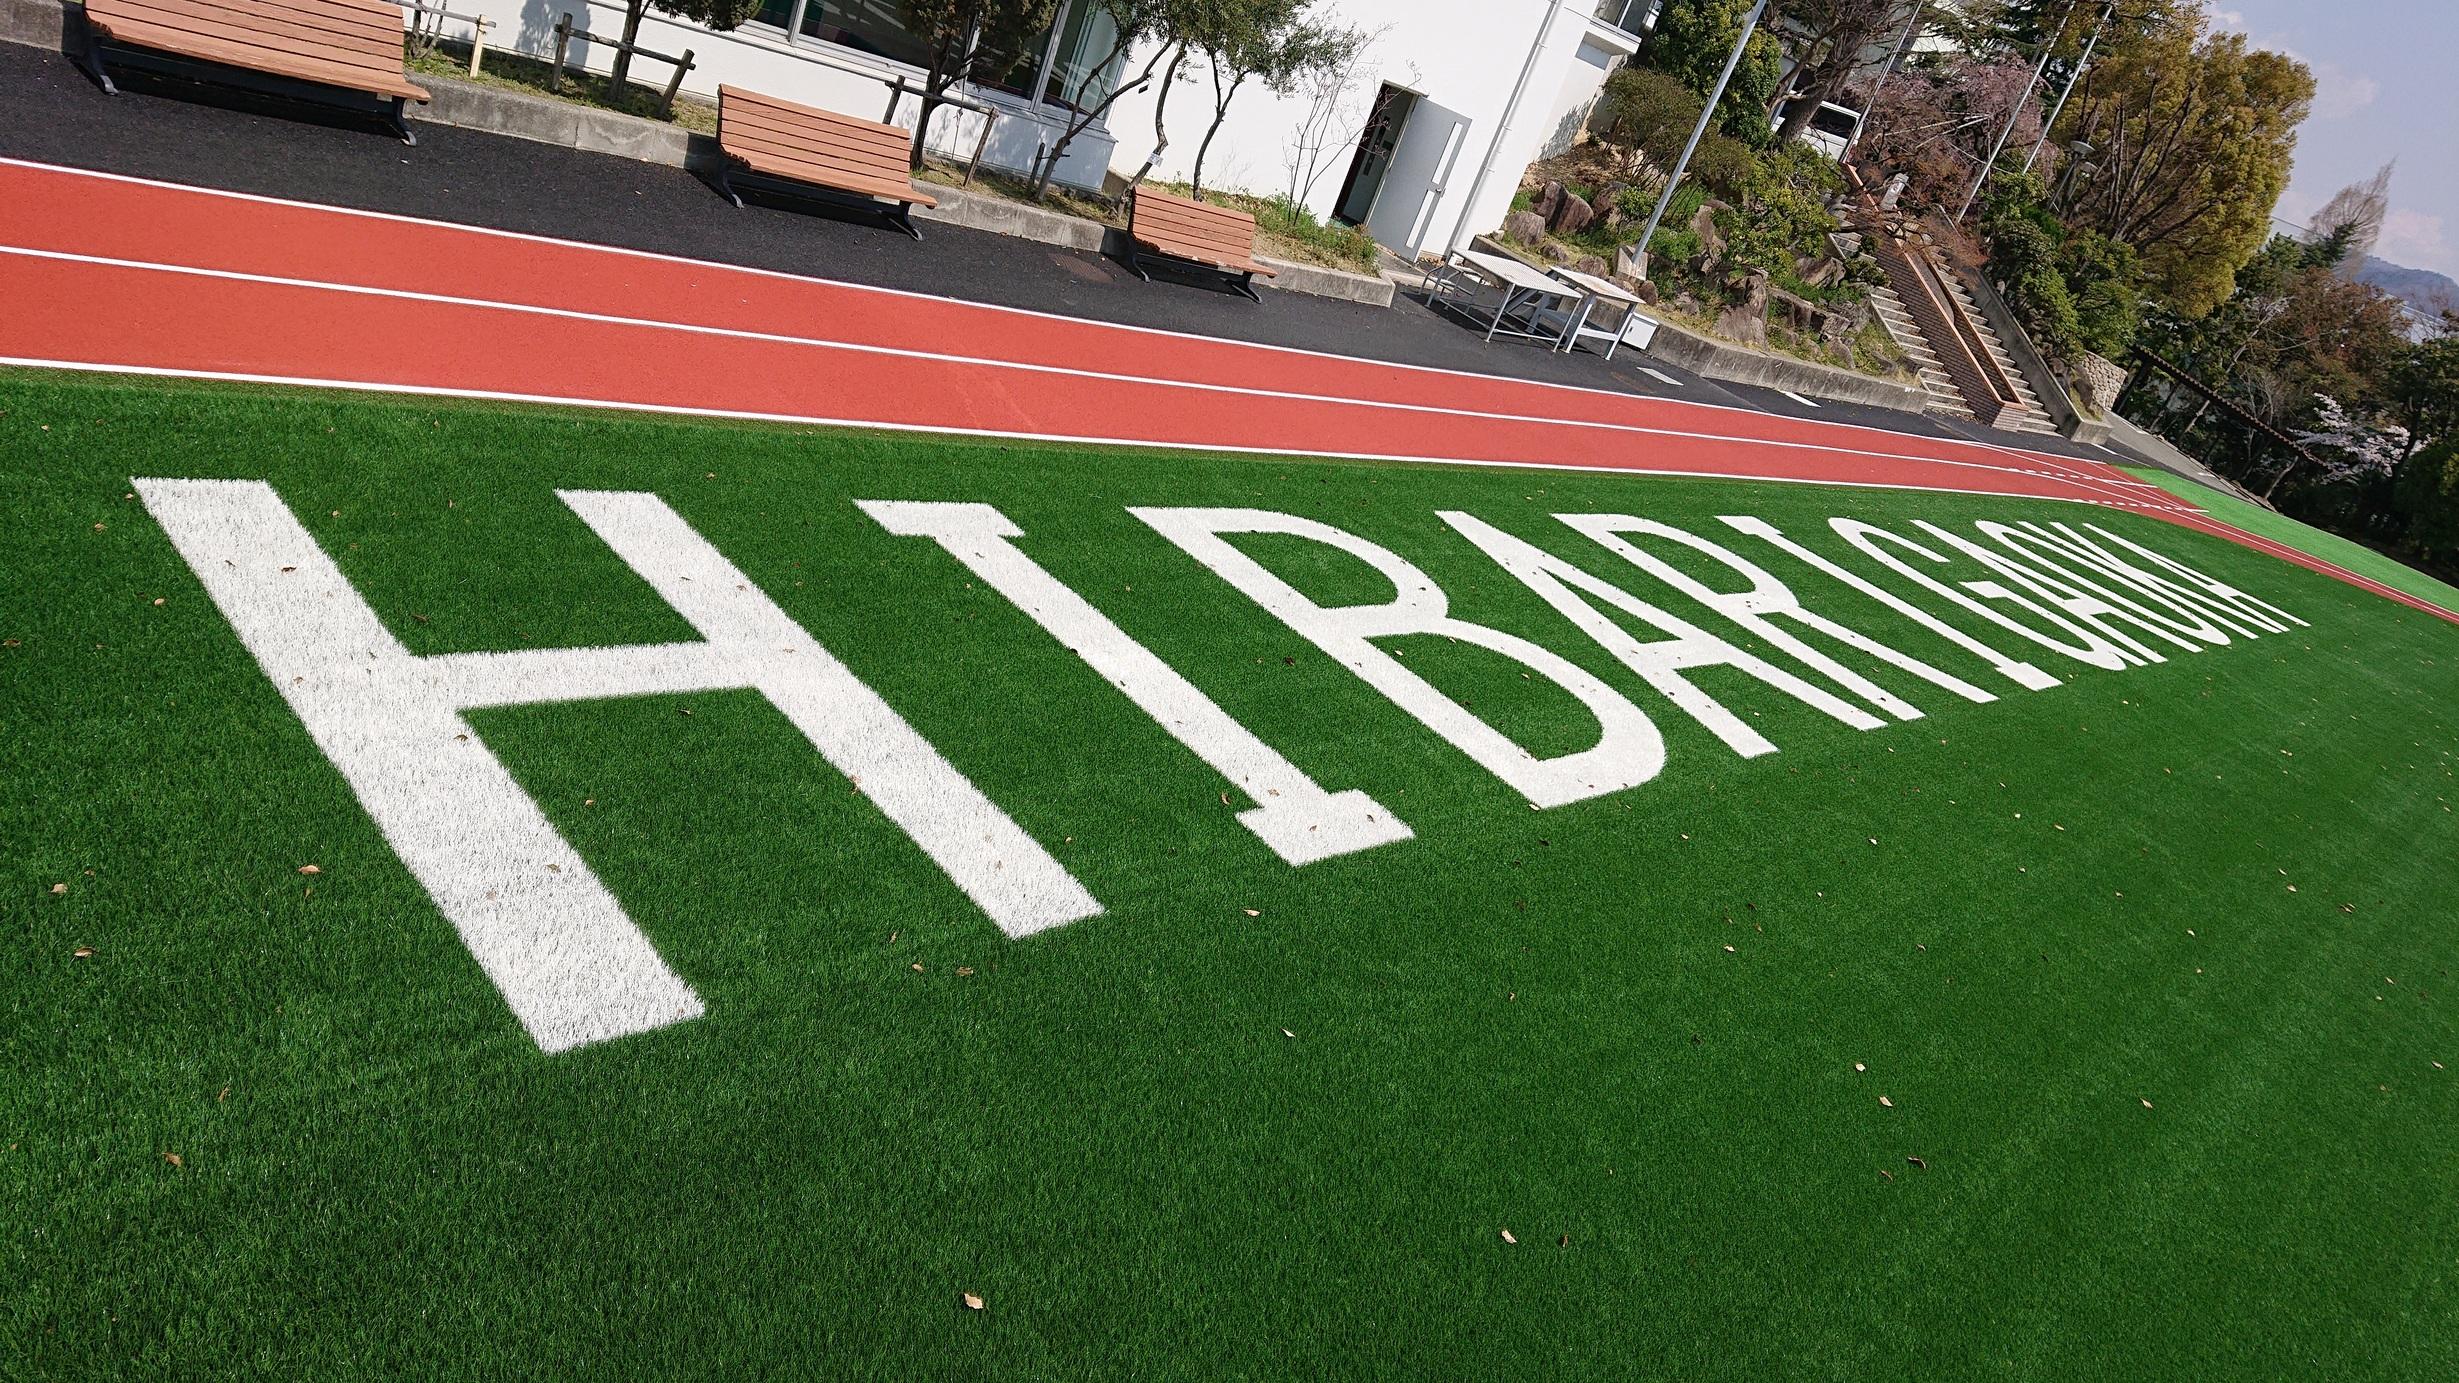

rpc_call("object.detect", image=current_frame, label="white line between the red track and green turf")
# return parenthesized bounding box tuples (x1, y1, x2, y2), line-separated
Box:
(0, 354, 2198, 514)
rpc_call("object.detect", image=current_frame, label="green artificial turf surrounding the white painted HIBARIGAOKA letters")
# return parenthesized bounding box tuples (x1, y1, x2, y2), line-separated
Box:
(0, 372, 2459, 1378)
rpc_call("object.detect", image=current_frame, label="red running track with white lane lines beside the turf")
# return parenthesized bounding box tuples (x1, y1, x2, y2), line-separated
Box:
(0, 160, 2459, 623)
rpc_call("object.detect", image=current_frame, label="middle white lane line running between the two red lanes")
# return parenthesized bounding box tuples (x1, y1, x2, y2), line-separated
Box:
(0, 246, 2193, 499)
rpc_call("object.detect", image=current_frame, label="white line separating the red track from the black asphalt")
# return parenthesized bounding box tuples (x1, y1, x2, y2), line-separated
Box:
(0, 157, 2157, 490)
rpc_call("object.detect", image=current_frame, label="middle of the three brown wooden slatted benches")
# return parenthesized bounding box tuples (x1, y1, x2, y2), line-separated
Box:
(718, 86, 939, 239)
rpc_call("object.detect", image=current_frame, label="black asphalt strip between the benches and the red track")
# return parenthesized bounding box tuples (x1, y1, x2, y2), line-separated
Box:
(0, 42, 2110, 460)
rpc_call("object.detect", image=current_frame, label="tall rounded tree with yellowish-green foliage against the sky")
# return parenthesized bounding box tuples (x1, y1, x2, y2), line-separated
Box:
(2061, 5, 2314, 317)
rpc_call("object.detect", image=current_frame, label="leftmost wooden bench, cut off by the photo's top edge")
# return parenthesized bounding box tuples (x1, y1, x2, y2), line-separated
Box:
(84, 0, 428, 145)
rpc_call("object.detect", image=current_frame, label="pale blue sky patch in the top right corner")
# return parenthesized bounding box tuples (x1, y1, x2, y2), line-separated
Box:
(2203, 0, 2459, 278)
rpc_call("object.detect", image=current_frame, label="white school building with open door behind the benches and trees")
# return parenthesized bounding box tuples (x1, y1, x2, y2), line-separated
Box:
(448, 0, 1657, 256)
